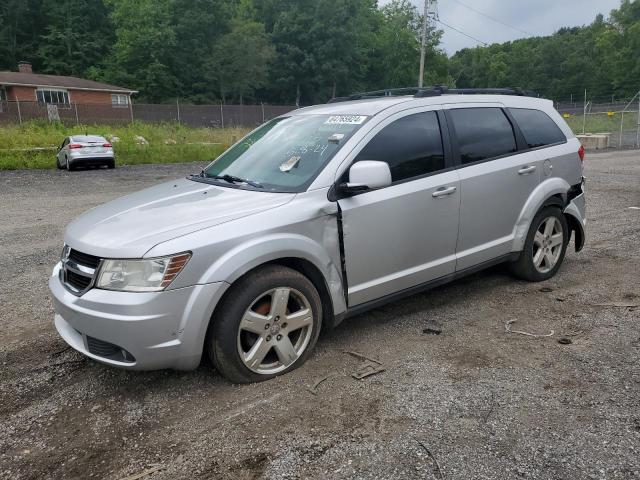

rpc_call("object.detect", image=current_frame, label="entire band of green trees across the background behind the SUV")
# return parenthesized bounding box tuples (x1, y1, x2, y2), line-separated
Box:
(0, 0, 640, 104)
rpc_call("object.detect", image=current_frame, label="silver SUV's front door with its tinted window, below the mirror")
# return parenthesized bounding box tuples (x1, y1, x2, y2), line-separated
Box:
(338, 110, 460, 307)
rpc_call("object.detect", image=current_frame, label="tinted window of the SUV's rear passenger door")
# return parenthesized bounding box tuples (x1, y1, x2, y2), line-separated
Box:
(449, 107, 517, 164)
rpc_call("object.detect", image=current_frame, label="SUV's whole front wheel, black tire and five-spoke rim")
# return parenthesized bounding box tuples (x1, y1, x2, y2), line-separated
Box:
(206, 265, 322, 383)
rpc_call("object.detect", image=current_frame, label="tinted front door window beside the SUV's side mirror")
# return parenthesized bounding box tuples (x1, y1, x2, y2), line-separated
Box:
(355, 112, 444, 182)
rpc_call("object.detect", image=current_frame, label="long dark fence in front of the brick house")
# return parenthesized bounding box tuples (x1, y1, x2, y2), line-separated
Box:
(0, 101, 296, 128)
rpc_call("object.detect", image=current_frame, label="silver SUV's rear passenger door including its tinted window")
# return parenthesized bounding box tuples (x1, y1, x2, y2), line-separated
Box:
(446, 104, 541, 271)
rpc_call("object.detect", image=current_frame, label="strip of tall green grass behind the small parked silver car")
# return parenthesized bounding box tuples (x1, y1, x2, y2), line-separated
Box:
(0, 121, 248, 170)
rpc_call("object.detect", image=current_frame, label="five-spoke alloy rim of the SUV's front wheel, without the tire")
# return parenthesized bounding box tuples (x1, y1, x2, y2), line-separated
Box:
(237, 287, 313, 375)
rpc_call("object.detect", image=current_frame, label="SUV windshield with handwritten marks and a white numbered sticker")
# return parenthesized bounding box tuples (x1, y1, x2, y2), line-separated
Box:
(200, 115, 367, 192)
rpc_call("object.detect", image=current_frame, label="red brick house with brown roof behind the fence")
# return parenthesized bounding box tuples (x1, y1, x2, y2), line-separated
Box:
(0, 62, 137, 121)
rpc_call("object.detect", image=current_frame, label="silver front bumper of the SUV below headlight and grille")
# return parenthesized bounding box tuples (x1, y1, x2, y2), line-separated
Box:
(49, 264, 228, 370)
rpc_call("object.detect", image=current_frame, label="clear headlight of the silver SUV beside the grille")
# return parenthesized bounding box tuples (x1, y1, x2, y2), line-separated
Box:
(96, 253, 191, 292)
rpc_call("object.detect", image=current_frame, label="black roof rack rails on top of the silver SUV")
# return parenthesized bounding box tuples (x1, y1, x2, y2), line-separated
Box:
(327, 85, 540, 103)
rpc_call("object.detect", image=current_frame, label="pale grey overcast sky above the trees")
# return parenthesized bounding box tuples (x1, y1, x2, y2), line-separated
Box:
(388, 0, 620, 55)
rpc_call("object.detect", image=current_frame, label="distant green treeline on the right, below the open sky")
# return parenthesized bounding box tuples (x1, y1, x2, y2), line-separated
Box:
(450, 0, 640, 101)
